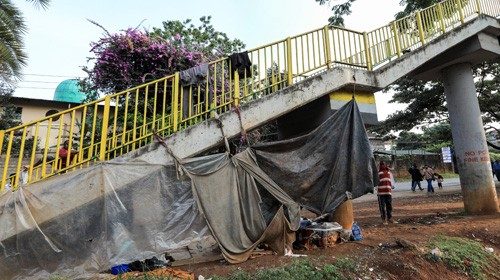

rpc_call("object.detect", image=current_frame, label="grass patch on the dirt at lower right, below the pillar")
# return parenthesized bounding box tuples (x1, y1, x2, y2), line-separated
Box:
(429, 236, 499, 279)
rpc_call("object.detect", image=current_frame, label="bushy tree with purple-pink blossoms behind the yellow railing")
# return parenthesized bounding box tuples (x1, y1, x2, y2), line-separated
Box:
(80, 16, 245, 99)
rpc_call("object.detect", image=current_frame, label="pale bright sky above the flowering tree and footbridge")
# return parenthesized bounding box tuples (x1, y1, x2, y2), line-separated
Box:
(15, 0, 402, 119)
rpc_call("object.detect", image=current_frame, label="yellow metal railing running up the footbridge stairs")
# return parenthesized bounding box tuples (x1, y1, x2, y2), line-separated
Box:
(0, 0, 500, 190)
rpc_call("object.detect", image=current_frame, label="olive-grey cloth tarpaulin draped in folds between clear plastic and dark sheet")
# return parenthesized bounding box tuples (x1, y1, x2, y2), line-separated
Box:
(182, 149, 300, 263)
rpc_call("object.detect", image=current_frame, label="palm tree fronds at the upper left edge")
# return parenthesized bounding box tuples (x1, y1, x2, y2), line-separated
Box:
(0, 0, 50, 82)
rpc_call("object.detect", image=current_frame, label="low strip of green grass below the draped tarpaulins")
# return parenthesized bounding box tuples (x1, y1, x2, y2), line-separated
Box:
(212, 258, 356, 280)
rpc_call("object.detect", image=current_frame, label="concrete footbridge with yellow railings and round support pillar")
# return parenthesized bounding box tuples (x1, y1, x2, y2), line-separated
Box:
(0, 0, 500, 213)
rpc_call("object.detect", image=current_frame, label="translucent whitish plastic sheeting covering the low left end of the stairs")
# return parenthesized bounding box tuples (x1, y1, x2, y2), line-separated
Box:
(0, 162, 210, 279)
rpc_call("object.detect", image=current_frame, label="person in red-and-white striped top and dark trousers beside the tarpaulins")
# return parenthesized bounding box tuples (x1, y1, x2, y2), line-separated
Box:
(377, 161, 395, 225)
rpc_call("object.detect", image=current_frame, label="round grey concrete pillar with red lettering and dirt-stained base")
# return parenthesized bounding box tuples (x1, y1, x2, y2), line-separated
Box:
(442, 63, 499, 214)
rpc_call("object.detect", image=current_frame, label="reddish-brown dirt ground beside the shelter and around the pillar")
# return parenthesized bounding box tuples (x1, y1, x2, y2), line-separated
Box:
(180, 188, 500, 280)
